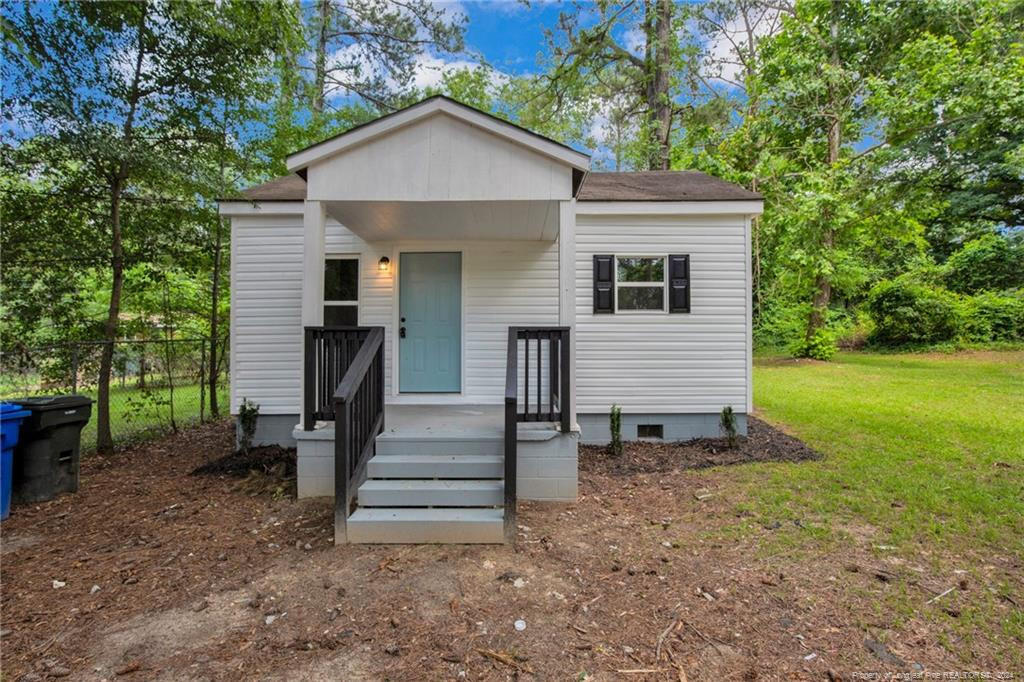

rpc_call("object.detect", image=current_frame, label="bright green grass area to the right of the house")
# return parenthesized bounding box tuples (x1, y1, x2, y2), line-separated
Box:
(735, 351, 1024, 553)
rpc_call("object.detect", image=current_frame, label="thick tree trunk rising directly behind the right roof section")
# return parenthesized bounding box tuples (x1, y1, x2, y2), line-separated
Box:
(644, 0, 673, 170)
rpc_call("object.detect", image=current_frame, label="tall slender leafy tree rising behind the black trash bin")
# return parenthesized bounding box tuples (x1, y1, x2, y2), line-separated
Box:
(3, 0, 289, 452)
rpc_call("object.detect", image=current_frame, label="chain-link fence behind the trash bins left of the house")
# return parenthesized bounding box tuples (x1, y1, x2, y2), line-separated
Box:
(0, 339, 230, 452)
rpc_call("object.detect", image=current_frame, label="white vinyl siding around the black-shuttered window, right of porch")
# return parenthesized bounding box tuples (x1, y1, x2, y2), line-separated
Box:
(575, 210, 750, 414)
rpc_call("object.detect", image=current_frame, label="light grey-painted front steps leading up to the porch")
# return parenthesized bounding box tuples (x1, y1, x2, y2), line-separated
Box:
(348, 427, 505, 544)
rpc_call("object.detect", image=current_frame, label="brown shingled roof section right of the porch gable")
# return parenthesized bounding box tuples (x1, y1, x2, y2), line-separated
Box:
(577, 171, 762, 202)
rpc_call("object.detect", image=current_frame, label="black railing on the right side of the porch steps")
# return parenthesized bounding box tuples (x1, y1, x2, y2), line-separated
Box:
(505, 327, 572, 542)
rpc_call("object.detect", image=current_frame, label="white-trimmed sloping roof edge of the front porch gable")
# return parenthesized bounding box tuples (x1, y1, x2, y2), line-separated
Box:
(287, 95, 590, 174)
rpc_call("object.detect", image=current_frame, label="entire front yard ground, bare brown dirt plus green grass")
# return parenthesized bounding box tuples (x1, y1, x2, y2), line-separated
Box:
(0, 353, 1024, 682)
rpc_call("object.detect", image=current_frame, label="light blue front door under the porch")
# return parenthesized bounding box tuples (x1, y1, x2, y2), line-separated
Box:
(398, 253, 462, 393)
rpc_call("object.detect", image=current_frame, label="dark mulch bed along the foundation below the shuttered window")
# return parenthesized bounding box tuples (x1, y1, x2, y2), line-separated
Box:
(580, 416, 822, 473)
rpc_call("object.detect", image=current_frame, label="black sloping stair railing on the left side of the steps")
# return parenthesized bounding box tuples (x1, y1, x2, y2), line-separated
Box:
(333, 327, 384, 544)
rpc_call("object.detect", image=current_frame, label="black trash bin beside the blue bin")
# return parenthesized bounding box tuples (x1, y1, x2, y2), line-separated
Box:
(11, 395, 92, 502)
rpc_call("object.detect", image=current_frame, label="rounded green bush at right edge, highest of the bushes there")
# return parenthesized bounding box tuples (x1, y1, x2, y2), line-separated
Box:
(944, 235, 1024, 294)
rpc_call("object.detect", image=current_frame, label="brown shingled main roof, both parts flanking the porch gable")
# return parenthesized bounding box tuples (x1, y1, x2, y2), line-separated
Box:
(234, 171, 762, 202)
